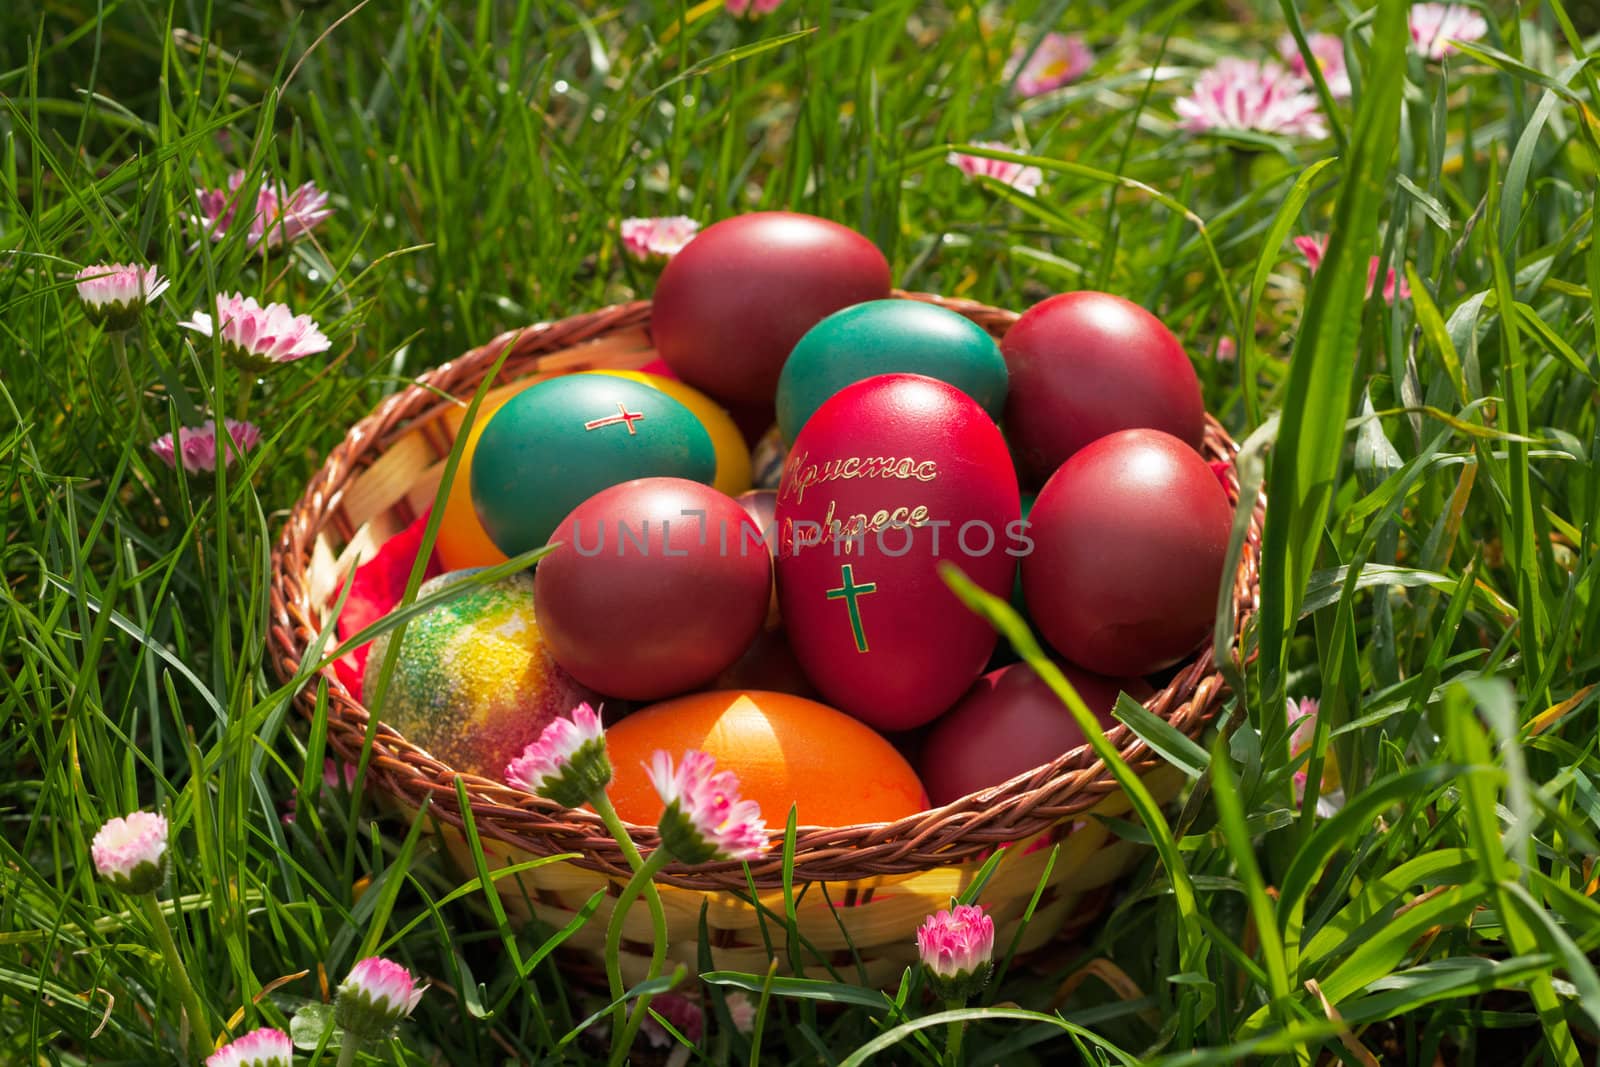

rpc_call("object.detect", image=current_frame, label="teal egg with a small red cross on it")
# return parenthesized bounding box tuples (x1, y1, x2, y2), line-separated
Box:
(472, 374, 717, 557)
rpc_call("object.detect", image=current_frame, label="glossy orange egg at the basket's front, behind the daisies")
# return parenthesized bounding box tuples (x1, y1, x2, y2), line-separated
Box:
(606, 689, 928, 827)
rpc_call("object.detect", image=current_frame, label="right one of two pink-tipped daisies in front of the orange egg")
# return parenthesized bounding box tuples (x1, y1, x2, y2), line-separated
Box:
(646, 749, 768, 864)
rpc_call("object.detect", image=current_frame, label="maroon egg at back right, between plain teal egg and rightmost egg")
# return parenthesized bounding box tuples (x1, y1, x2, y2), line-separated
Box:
(1000, 291, 1205, 485)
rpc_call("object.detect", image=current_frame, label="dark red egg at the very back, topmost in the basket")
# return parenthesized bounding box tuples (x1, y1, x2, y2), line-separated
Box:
(651, 211, 890, 405)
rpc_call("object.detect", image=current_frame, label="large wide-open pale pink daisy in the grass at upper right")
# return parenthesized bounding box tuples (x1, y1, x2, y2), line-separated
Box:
(1174, 56, 1328, 139)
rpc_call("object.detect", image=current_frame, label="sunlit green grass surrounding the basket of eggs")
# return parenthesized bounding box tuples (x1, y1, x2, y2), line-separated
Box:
(0, 0, 1600, 1064)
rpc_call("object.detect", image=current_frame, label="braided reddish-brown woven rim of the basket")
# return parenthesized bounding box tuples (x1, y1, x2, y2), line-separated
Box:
(269, 290, 1266, 891)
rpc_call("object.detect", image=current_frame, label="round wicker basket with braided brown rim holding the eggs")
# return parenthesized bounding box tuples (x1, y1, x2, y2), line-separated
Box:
(270, 293, 1262, 985)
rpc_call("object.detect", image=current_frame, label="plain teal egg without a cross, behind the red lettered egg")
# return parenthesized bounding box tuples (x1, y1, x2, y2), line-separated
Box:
(778, 301, 1006, 442)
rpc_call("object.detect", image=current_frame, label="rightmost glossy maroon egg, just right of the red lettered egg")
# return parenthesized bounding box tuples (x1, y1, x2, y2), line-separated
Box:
(1022, 430, 1234, 677)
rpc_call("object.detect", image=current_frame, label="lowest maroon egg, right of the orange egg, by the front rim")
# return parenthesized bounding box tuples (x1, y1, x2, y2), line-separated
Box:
(917, 664, 1152, 805)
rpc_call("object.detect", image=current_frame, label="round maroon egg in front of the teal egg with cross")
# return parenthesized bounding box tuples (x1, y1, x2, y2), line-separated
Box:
(533, 478, 771, 701)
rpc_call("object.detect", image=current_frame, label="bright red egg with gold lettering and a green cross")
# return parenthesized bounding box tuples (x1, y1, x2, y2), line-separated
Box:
(778, 374, 1021, 729)
